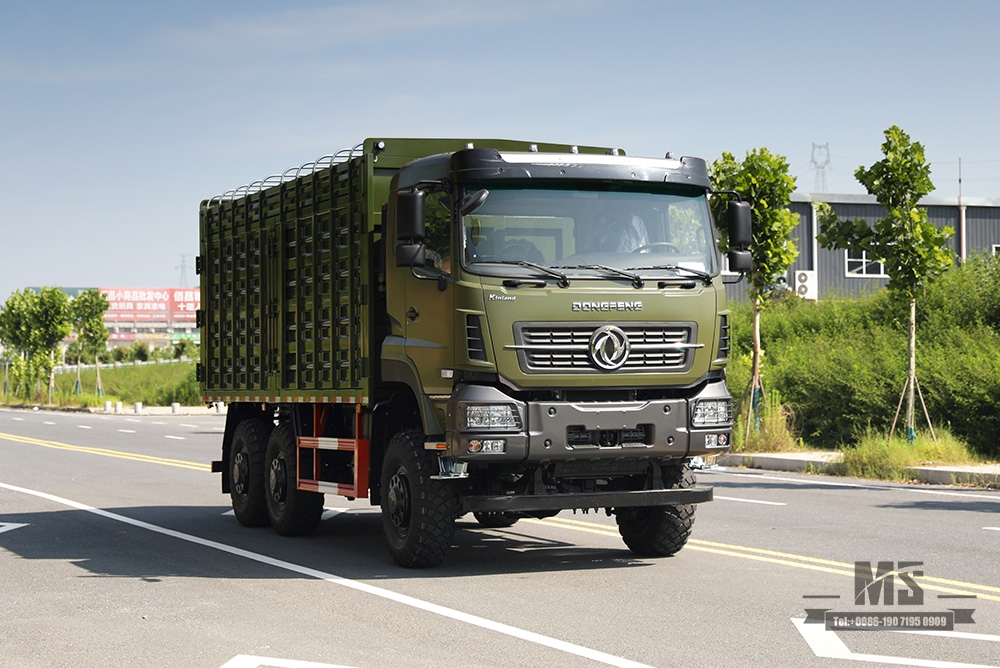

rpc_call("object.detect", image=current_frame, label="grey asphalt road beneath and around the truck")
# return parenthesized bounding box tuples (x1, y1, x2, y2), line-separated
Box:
(0, 410, 1000, 668)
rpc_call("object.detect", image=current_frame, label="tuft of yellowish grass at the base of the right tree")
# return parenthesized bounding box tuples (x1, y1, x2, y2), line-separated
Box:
(844, 427, 983, 482)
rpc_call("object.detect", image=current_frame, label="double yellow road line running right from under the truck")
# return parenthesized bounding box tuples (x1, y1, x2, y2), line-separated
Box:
(523, 517, 1000, 601)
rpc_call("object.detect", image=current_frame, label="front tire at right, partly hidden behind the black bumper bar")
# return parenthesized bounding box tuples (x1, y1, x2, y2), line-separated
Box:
(615, 465, 695, 557)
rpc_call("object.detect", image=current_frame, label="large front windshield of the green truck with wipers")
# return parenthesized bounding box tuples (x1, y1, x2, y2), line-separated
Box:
(462, 183, 717, 277)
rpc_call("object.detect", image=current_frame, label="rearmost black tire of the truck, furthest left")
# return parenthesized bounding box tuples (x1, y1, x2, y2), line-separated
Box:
(227, 417, 274, 527)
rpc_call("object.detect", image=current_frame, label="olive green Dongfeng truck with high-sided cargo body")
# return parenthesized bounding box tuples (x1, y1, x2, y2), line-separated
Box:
(198, 139, 750, 567)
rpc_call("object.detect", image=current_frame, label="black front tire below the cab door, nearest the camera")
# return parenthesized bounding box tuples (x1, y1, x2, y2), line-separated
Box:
(382, 431, 459, 568)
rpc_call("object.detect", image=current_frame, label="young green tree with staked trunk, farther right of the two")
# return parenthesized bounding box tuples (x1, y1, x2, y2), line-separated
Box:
(817, 125, 955, 441)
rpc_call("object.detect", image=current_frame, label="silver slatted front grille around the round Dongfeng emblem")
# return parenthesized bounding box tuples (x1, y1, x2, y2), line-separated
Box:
(508, 322, 702, 373)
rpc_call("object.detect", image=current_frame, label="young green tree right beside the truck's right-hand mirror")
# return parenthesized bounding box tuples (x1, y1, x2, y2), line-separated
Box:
(711, 148, 799, 429)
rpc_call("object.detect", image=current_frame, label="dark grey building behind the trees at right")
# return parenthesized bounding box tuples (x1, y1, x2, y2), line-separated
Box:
(727, 193, 1000, 301)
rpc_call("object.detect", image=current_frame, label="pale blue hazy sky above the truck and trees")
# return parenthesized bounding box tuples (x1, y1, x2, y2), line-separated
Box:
(0, 0, 1000, 304)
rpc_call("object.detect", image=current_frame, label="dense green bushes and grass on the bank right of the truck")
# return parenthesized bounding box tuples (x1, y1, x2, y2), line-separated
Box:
(728, 256, 1000, 470)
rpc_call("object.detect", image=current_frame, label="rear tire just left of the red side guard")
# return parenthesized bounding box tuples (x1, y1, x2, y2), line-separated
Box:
(265, 422, 323, 536)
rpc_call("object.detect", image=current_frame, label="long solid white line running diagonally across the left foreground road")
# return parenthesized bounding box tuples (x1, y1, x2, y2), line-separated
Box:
(0, 482, 651, 668)
